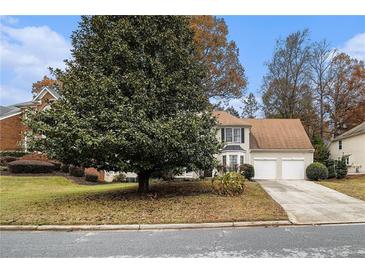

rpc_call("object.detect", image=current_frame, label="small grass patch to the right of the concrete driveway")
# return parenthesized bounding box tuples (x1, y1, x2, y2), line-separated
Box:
(320, 175, 365, 201)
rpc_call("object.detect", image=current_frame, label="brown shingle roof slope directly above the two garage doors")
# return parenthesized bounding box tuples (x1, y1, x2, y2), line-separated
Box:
(242, 119, 313, 149)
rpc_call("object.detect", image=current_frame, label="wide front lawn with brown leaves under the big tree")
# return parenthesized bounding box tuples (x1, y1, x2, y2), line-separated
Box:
(0, 176, 287, 224)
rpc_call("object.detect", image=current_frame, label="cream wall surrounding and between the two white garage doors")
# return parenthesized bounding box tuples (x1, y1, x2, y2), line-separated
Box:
(250, 150, 313, 179)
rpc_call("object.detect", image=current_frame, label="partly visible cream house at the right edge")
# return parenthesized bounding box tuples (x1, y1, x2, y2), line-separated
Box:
(329, 121, 365, 173)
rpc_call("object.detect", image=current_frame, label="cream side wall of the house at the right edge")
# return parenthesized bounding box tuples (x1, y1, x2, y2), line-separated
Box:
(329, 134, 365, 173)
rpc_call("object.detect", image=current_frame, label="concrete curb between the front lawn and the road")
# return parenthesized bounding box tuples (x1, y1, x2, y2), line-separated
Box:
(0, 221, 292, 231)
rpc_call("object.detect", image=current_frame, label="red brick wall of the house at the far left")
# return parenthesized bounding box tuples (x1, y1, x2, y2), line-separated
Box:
(0, 114, 24, 151)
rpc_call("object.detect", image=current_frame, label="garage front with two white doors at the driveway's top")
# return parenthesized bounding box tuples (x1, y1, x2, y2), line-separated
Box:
(252, 153, 313, 180)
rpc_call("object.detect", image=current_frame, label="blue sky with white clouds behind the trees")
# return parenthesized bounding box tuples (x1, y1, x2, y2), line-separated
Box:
(0, 16, 365, 109)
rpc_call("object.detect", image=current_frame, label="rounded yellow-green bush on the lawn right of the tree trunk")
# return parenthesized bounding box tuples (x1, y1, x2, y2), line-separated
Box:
(212, 172, 245, 196)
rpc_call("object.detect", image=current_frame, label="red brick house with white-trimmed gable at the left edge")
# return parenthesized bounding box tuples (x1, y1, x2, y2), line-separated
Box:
(0, 87, 60, 151)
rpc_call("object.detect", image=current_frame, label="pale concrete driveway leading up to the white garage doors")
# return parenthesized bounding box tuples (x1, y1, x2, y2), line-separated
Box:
(259, 180, 365, 224)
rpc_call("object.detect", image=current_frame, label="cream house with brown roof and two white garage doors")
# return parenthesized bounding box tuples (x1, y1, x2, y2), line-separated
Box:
(213, 111, 314, 179)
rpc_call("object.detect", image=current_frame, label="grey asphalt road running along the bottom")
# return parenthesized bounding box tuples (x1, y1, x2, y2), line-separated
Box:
(0, 224, 365, 258)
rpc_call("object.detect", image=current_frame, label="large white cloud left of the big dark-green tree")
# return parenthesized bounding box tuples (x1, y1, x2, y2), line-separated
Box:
(0, 19, 71, 104)
